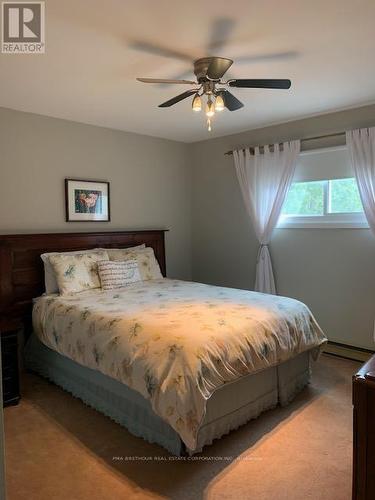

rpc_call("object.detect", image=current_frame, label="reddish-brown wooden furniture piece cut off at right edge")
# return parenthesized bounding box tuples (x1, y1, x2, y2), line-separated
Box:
(353, 355, 375, 500)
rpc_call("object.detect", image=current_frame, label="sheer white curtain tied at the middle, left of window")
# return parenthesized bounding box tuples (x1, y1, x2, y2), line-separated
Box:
(233, 141, 300, 294)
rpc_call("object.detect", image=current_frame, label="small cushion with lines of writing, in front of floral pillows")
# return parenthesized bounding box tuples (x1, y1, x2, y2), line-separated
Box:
(98, 259, 142, 290)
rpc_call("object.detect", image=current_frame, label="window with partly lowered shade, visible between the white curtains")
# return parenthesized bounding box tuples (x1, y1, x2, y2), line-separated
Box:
(278, 148, 368, 228)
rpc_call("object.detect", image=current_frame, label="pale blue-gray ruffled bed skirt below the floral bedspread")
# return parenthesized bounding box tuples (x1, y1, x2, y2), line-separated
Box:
(25, 335, 310, 456)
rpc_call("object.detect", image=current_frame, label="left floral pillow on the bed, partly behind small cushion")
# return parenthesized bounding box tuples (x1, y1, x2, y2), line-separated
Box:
(49, 250, 109, 295)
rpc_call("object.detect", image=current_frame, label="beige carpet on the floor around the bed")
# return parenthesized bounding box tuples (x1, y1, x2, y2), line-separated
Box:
(5, 355, 359, 500)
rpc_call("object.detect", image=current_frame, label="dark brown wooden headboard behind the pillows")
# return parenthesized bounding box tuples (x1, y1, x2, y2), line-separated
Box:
(0, 230, 166, 324)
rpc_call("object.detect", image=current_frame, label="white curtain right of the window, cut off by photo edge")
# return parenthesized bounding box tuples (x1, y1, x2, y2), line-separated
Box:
(346, 127, 375, 234)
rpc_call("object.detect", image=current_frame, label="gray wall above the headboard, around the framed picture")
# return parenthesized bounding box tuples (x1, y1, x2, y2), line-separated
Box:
(0, 108, 191, 278)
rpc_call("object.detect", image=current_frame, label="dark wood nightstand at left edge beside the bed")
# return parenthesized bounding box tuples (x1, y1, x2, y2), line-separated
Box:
(0, 319, 22, 406)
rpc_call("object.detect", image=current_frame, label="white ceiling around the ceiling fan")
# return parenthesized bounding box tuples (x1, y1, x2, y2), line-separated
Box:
(0, 0, 375, 142)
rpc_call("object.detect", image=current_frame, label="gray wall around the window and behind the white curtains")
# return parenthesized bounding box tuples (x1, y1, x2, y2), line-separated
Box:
(192, 106, 375, 349)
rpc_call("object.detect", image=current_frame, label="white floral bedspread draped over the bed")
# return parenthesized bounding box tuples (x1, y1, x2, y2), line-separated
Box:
(33, 279, 326, 450)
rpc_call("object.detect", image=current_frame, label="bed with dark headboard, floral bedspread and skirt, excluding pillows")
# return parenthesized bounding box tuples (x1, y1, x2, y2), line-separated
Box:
(0, 231, 326, 455)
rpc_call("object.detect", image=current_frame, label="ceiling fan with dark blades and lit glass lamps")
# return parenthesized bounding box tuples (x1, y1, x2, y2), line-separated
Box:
(137, 57, 291, 131)
